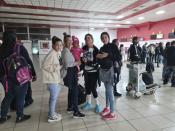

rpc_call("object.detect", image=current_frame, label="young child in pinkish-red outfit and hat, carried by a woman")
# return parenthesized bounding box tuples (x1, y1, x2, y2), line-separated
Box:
(70, 36, 83, 72)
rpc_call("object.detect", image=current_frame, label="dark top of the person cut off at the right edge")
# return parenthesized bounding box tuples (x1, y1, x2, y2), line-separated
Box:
(166, 46, 175, 66)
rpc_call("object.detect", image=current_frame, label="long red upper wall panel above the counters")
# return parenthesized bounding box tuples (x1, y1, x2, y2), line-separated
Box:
(117, 18, 175, 40)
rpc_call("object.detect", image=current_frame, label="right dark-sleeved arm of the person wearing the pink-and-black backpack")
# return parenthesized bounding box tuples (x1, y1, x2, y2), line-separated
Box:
(20, 45, 36, 79)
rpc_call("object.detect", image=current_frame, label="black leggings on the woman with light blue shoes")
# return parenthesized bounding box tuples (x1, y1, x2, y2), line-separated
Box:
(84, 72, 98, 98)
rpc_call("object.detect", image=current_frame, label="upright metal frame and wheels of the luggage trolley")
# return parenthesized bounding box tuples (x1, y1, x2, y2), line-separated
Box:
(126, 63, 142, 99)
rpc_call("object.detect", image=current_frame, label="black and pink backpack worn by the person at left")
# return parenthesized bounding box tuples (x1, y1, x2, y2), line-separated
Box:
(3, 44, 32, 92)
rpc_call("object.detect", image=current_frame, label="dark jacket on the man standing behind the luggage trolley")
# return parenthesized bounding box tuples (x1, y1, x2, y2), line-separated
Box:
(129, 44, 141, 62)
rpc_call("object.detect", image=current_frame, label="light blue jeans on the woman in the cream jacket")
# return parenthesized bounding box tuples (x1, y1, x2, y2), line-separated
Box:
(47, 83, 61, 117)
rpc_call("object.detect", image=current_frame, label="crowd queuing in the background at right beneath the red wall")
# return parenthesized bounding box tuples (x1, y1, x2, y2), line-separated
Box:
(128, 37, 175, 87)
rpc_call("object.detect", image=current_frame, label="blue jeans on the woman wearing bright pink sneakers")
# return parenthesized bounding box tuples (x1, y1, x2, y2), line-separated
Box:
(104, 82, 115, 113)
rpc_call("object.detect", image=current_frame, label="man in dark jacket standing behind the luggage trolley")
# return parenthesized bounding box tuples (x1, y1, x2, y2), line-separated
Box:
(129, 37, 141, 63)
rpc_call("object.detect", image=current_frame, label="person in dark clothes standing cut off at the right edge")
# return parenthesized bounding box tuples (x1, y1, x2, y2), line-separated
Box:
(164, 41, 175, 87)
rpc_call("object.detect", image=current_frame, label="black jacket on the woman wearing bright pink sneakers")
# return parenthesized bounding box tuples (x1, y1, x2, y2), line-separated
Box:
(99, 43, 121, 69)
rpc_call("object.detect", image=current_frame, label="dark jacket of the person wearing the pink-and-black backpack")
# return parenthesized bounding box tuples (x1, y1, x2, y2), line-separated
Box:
(0, 45, 36, 77)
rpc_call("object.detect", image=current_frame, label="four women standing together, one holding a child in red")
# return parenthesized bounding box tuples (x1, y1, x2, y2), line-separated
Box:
(42, 32, 122, 122)
